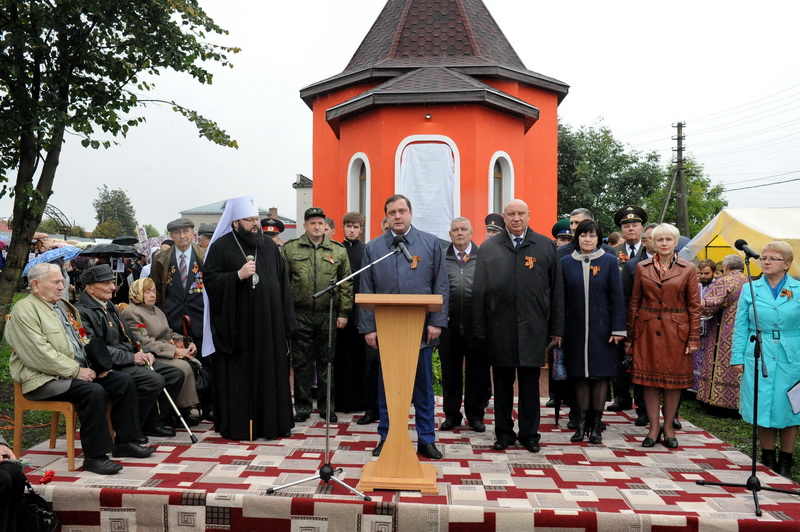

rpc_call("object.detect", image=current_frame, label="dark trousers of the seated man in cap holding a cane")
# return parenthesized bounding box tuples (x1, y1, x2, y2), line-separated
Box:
(115, 361, 184, 430)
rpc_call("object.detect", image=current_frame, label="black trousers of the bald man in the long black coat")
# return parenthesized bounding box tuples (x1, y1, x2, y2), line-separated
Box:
(492, 366, 541, 445)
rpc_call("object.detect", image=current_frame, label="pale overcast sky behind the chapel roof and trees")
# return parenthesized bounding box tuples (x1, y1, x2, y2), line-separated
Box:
(0, 0, 800, 230)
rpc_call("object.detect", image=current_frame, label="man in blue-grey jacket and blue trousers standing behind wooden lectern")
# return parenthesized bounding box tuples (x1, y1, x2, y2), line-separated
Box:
(358, 194, 449, 460)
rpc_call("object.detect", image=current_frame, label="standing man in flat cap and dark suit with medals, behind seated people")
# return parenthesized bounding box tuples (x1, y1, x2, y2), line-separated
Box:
(150, 218, 208, 419)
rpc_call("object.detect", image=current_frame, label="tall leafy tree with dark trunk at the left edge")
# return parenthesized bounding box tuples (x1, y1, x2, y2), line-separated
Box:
(0, 0, 239, 332)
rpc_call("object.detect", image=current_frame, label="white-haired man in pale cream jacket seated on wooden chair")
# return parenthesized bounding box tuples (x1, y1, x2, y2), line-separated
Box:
(5, 264, 155, 475)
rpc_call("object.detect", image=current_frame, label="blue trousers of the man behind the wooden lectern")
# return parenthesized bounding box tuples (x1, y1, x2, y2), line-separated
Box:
(378, 347, 436, 445)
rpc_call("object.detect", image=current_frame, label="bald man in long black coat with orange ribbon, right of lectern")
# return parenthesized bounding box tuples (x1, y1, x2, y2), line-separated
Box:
(472, 199, 564, 453)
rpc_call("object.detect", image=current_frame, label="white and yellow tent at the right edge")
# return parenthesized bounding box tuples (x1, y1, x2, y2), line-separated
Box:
(680, 208, 800, 278)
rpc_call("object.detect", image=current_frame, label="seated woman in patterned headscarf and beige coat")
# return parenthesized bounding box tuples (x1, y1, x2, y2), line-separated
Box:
(122, 278, 200, 425)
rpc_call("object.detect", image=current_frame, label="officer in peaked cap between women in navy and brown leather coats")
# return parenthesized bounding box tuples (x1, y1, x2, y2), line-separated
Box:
(608, 205, 647, 419)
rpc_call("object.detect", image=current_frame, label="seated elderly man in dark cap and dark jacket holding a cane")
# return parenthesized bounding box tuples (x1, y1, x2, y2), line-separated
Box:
(76, 264, 183, 443)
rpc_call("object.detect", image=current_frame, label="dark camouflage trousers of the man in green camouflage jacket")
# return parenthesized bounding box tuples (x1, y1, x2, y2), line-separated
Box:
(292, 313, 336, 416)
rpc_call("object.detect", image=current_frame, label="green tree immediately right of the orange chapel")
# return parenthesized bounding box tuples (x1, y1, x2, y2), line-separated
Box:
(558, 123, 664, 234)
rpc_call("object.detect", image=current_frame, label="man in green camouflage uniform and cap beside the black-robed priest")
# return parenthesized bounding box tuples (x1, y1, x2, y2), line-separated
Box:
(284, 207, 353, 423)
